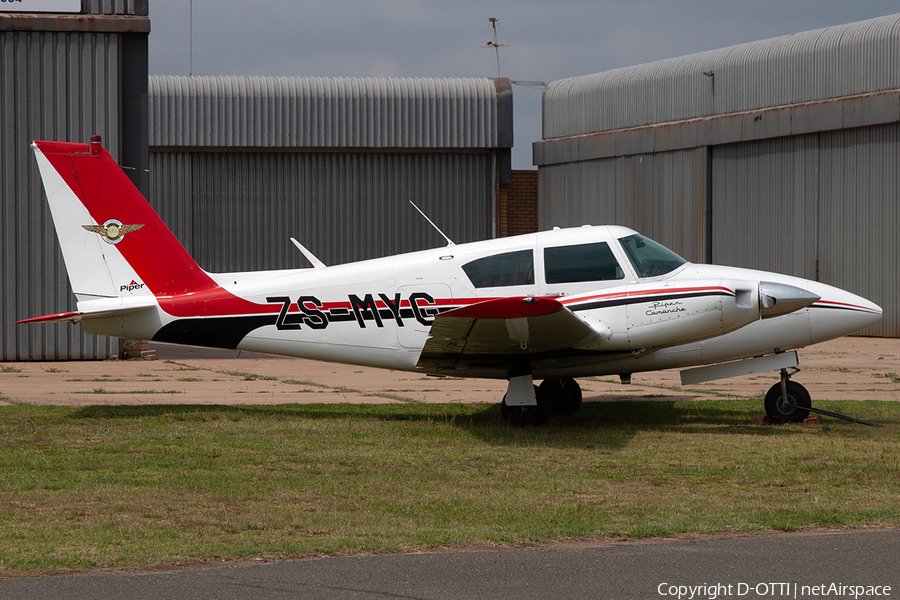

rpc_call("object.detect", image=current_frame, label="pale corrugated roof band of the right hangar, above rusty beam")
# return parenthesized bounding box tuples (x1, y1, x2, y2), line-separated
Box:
(543, 15, 900, 140)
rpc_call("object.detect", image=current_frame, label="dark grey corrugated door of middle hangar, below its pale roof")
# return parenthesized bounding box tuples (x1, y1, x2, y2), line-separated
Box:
(150, 151, 494, 272)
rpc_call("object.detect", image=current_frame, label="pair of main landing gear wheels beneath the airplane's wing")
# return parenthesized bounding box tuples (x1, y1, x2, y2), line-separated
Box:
(500, 376, 581, 427)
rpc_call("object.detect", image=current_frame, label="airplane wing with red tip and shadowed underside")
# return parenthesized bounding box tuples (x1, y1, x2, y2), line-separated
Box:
(417, 297, 604, 372)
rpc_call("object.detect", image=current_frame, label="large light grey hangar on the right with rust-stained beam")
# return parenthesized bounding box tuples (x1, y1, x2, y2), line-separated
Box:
(534, 15, 900, 337)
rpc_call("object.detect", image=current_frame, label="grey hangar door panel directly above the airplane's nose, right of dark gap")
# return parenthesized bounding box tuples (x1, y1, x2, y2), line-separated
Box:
(711, 135, 819, 279)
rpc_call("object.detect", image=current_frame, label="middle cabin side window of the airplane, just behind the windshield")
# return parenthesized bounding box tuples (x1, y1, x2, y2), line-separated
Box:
(544, 242, 625, 283)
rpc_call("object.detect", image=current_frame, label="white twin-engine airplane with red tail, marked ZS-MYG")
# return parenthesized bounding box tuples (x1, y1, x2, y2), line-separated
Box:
(20, 136, 881, 425)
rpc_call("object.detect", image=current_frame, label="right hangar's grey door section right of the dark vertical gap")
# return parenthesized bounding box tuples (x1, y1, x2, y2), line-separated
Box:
(711, 123, 900, 337)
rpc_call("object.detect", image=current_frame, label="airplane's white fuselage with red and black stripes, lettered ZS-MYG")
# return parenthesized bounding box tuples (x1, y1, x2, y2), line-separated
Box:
(84, 226, 880, 379)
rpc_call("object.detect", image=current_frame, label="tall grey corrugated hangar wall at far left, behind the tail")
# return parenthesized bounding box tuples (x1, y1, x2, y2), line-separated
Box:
(0, 0, 150, 360)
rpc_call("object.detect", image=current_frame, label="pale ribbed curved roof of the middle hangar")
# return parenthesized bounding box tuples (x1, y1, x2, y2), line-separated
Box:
(149, 76, 512, 149)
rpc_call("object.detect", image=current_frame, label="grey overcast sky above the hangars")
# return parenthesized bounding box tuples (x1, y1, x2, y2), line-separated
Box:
(150, 0, 900, 169)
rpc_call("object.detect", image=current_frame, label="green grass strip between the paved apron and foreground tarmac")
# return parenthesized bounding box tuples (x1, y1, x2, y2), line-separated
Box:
(0, 400, 900, 576)
